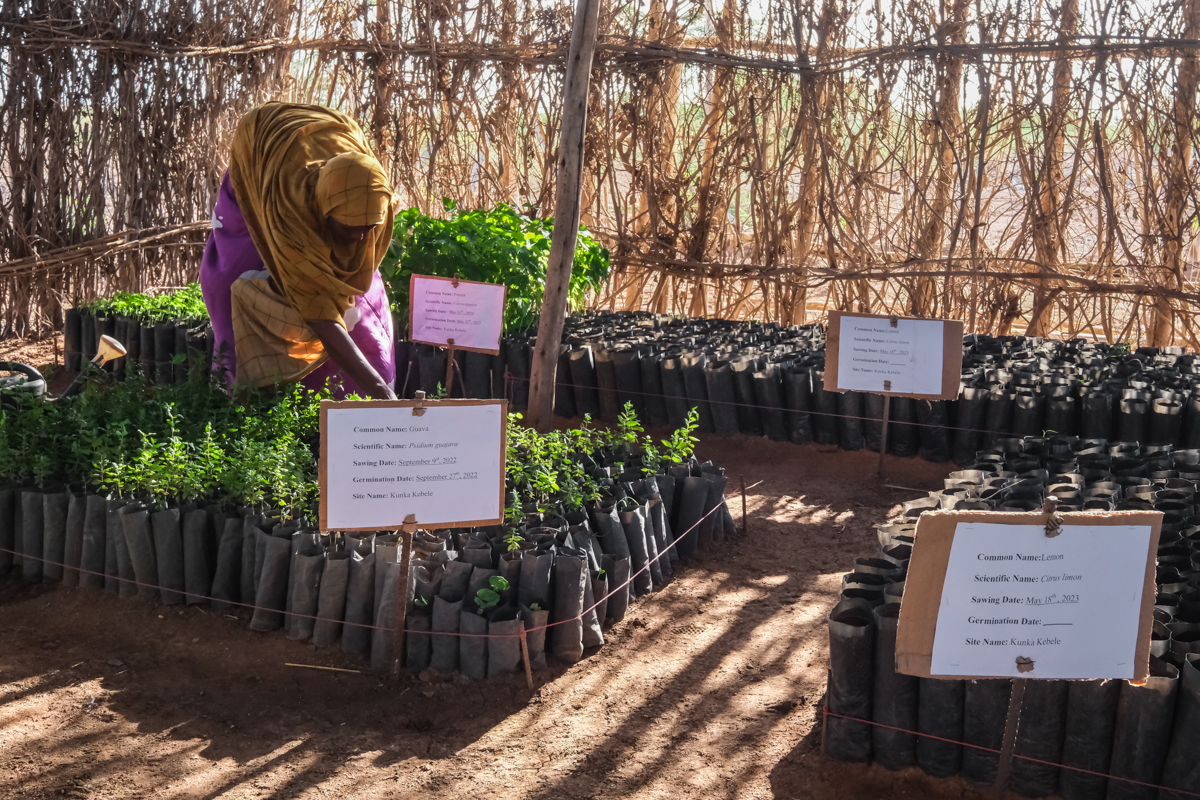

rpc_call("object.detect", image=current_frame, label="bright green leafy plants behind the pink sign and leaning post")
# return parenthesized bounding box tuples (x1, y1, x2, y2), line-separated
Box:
(379, 199, 608, 330)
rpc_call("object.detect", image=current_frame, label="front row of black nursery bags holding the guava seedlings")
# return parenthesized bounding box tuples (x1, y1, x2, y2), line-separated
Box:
(0, 464, 734, 678)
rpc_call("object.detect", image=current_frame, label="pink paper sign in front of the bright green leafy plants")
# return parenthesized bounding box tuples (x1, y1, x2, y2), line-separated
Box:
(408, 275, 508, 353)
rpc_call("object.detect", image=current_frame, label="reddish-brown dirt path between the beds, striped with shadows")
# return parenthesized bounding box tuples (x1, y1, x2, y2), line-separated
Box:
(0, 335, 983, 800)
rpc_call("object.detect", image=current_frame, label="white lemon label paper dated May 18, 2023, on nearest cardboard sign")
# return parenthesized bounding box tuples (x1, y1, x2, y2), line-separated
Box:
(930, 523, 1151, 679)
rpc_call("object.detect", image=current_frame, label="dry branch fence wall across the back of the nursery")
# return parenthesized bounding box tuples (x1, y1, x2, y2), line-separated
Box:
(0, 0, 1200, 347)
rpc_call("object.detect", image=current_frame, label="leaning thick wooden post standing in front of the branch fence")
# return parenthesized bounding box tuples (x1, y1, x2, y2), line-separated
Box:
(529, 0, 600, 433)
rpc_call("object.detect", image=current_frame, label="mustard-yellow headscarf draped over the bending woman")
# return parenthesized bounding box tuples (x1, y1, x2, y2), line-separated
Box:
(229, 103, 395, 326)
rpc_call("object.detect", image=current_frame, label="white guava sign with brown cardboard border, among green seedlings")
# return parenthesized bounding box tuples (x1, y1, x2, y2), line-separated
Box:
(320, 401, 506, 530)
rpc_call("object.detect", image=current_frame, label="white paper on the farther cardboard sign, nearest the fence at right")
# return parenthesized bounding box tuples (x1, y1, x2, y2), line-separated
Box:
(838, 315, 944, 395)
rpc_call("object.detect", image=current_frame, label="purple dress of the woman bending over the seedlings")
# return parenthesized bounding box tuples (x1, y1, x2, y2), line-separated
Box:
(200, 173, 396, 397)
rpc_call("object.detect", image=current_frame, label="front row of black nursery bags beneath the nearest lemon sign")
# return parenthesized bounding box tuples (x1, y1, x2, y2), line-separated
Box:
(824, 593, 1200, 800)
